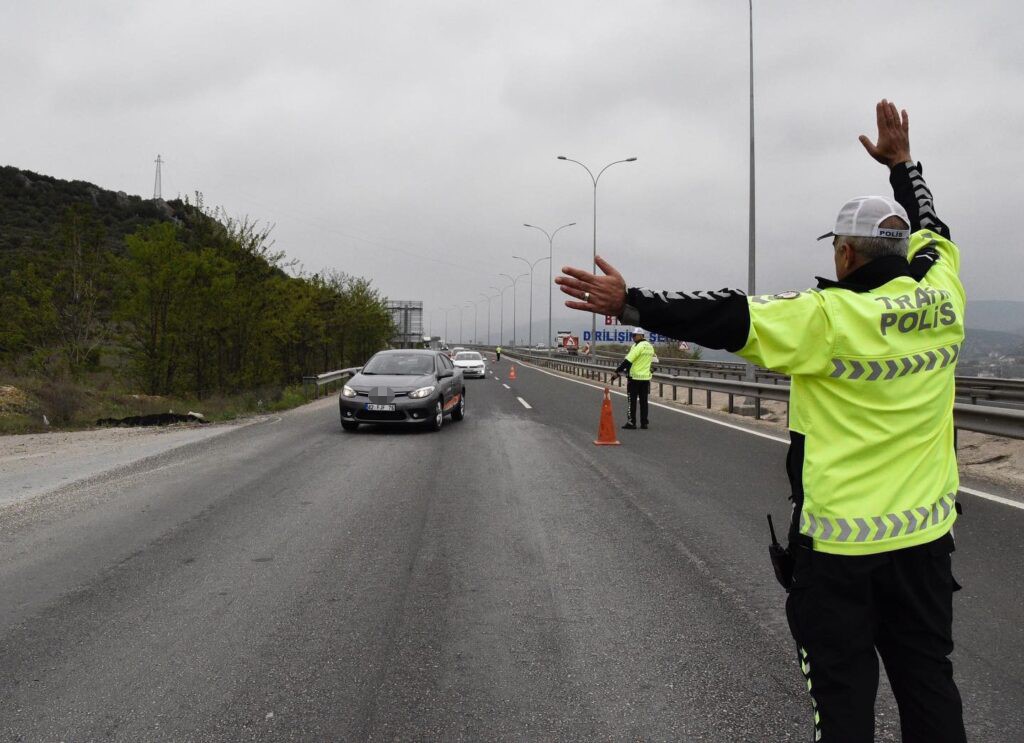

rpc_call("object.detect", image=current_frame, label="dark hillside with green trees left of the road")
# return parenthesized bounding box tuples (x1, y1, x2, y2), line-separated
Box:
(0, 168, 392, 427)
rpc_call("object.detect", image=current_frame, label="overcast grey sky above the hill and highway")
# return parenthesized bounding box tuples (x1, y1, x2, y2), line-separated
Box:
(0, 0, 1024, 341)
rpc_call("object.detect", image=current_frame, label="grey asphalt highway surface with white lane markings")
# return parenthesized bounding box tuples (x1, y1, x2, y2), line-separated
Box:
(0, 361, 1024, 742)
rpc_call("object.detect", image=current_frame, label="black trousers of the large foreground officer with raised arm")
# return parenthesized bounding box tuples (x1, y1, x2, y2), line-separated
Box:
(785, 534, 967, 743)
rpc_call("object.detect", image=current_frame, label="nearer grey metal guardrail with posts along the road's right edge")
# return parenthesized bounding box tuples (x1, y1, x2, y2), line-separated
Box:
(507, 351, 1024, 439)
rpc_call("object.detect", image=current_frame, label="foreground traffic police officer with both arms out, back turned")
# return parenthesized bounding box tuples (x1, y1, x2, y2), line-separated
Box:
(557, 100, 966, 743)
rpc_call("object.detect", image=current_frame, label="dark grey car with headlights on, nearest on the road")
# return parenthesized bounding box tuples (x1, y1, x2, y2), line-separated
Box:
(338, 350, 466, 431)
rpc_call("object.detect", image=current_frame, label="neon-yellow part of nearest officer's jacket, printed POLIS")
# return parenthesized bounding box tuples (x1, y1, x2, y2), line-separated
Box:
(738, 230, 966, 555)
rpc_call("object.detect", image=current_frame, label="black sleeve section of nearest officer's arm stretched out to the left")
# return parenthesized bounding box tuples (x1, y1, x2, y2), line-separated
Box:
(622, 289, 751, 351)
